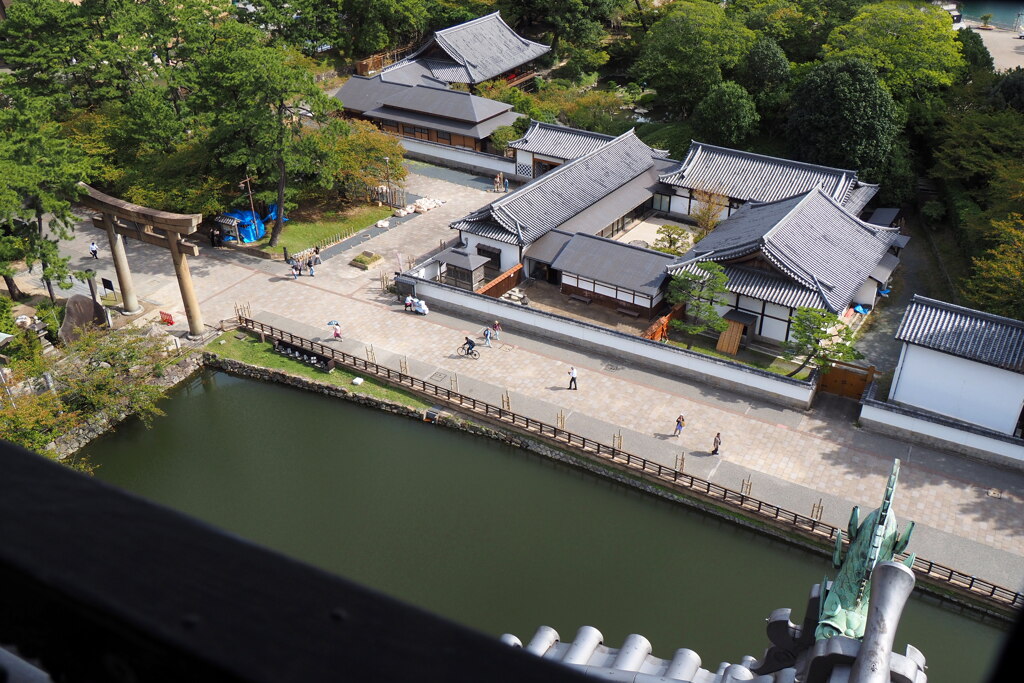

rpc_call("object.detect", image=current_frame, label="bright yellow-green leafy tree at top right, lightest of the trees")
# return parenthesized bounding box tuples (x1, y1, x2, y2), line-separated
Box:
(822, 2, 966, 100)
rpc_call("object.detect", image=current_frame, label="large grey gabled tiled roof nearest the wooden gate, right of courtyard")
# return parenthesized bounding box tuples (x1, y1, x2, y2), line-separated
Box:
(670, 189, 899, 313)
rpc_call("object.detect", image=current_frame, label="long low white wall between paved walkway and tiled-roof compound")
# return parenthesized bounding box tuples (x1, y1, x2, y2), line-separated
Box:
(407, 281, 814, 407)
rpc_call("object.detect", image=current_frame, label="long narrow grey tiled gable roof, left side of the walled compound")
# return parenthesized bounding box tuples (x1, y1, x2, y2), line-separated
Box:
(452, 130, 654, 245)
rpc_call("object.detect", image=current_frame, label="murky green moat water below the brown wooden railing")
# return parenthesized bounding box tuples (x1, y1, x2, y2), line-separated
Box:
(88, 374, 1004, 683)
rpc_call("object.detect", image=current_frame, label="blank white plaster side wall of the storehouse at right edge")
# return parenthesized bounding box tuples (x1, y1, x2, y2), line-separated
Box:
(889, 344, 1024, 434)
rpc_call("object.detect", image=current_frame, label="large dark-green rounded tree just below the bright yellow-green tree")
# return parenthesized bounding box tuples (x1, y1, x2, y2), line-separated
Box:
(786, 59, 902, 171)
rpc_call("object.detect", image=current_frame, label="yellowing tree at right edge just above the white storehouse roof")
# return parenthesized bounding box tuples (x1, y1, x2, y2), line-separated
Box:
(964, 213, 1024, 321)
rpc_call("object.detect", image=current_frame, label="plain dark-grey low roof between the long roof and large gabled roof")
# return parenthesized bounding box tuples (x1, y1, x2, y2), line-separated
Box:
(551, 232, 675, 296)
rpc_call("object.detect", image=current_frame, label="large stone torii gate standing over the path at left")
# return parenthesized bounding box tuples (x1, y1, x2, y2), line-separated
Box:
(78, 182, 203, 338)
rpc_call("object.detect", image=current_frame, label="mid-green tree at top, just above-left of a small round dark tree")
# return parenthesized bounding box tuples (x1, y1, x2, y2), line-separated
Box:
(633, 0, 755, 115)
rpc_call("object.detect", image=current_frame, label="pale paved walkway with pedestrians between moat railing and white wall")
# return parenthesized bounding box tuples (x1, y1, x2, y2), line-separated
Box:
(19, 167, 1024, 590)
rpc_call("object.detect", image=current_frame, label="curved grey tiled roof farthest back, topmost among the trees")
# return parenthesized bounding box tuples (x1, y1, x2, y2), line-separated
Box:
(399, 12, 551, 84)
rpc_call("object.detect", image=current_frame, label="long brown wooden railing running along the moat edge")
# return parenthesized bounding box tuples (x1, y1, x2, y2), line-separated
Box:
(239, 315, 1024, 609)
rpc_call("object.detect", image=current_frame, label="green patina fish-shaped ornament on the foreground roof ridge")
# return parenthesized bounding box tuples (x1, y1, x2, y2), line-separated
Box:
(814, 460, 913, 640)
